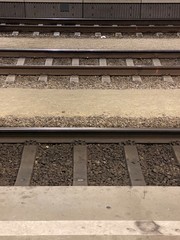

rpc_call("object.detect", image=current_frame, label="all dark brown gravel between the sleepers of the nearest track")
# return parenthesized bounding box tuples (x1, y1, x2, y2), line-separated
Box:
(0, 143, 180, 186)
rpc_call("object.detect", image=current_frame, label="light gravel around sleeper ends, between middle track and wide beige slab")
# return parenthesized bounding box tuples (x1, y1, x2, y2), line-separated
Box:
(0, 75, 180, 90)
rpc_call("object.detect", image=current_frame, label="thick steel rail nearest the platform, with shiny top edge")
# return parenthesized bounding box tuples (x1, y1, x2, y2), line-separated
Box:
(0, 127, 180, 143)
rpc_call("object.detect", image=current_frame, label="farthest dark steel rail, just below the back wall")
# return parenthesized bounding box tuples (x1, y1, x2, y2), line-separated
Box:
(0, 18, 180, 26)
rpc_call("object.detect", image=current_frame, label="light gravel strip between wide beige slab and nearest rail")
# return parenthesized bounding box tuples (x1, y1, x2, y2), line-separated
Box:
(0, 115, 180, 128)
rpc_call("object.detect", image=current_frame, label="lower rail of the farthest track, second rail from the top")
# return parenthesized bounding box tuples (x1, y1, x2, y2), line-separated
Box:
(0, 24, 180, 33)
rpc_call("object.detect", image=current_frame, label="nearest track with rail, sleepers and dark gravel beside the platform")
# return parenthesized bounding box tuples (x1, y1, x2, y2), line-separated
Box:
(0, 128, 180, 186)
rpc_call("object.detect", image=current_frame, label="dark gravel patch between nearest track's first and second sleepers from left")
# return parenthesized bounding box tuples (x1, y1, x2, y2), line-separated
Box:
(31, 144, 73, 186)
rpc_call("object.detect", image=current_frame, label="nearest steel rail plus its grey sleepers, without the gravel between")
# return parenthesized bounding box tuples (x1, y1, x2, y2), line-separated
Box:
(0, 128, 180, 186)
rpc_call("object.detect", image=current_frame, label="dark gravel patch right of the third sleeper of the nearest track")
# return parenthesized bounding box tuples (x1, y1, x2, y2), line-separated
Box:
(138, 144, 180, 186)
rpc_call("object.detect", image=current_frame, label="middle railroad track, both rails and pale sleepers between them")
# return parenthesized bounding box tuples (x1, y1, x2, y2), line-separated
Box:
(0, 49, 180, 76)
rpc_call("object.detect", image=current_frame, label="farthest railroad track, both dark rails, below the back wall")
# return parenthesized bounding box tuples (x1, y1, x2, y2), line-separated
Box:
(0, 18, 180, 34)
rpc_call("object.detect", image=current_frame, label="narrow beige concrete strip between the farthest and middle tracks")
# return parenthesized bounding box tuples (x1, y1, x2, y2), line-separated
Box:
(0, 37, 180, 50)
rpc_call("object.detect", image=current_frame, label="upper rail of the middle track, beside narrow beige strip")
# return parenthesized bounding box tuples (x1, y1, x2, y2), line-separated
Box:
(0, 49, 180, 59)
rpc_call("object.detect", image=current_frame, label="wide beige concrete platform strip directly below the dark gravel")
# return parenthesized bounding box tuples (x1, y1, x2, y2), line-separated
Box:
(0, 186, 180, 221)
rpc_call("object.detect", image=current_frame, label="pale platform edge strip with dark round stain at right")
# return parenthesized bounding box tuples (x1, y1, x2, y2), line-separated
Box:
(0, 220, 180, 236)
